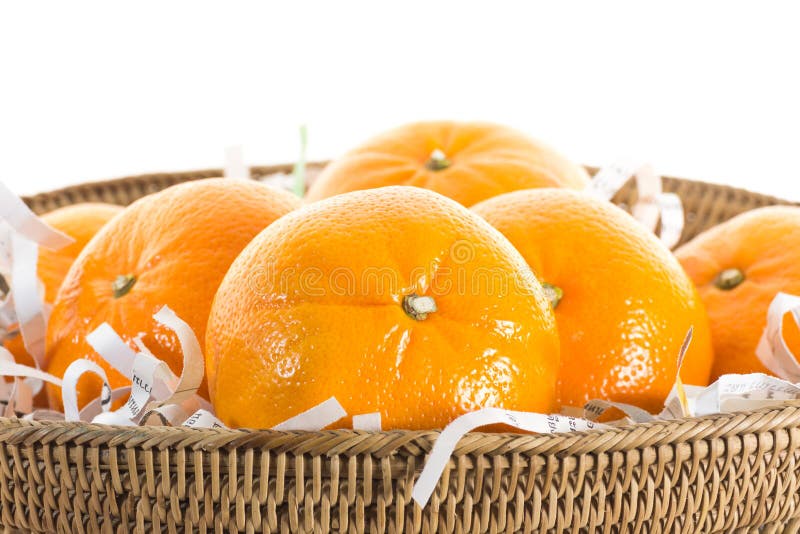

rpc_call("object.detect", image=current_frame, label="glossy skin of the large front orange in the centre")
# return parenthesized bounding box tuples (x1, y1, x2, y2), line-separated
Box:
(206, 186, 559, 429)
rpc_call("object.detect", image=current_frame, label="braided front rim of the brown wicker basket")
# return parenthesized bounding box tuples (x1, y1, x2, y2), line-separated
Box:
(6, 403, 800, 457)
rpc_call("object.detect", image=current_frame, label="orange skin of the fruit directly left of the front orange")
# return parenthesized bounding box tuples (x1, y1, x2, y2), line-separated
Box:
(46, 178, 300, 408)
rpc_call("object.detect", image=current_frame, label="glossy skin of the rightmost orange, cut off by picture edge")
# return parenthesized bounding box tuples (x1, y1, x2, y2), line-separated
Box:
(675, 206, 800, 379)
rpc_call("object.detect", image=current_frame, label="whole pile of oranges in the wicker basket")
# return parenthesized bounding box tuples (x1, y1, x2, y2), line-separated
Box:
(7, 122, 780, 429)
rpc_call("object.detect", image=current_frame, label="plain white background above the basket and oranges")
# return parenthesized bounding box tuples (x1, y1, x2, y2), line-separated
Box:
(0, 1, 800, 200)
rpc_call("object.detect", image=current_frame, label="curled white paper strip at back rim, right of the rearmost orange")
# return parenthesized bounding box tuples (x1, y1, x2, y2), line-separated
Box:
(586, 161, 684, 248)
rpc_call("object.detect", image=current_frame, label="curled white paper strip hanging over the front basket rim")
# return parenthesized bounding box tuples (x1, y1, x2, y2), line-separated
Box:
(411, 408, 608, 507)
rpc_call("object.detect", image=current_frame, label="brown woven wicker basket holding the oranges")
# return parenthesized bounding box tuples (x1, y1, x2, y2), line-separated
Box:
(0, 166, 800, 532)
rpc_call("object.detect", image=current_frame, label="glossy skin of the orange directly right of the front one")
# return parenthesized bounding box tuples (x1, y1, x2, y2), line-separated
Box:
(473, 189, 713, 412)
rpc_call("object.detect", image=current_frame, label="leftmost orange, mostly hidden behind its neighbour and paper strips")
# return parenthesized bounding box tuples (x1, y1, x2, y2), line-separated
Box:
(4, 202, 122, 365)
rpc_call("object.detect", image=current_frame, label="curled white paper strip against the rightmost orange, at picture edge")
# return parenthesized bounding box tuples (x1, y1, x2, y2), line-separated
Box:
(756, 293, 800, 383)
